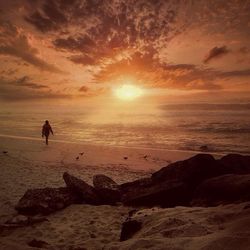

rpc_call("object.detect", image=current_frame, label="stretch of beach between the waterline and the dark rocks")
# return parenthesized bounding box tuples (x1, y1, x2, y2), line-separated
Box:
(0, 137, 199, 221)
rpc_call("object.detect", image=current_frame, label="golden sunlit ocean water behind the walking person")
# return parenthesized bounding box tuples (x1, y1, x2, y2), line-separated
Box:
(0, 104, 250, 154)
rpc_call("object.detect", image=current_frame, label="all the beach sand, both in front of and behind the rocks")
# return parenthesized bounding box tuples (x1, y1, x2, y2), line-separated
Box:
(0, 138, 250, 250)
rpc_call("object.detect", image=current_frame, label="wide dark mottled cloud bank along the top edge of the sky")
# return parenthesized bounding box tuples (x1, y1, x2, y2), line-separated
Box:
(25, 0, 178, 41)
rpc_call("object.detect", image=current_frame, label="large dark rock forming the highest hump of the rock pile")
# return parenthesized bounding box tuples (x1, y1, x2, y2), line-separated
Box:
(152, 154, 224, 188)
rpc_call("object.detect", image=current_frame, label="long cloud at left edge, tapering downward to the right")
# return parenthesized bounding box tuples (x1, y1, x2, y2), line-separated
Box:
(0, 23, 63, 73)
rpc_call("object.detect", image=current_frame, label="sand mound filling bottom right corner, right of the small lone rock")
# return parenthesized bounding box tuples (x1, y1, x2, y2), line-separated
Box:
(108, 202, 250, 250)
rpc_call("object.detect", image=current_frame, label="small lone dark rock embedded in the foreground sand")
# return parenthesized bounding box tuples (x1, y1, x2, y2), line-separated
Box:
(120, 220, 142, 241)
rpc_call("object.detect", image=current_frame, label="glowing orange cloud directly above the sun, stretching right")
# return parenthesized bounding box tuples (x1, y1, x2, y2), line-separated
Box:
(93, 49, 221, 90)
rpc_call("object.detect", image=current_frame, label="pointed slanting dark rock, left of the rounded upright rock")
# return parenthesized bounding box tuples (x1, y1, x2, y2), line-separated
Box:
(63, 172, 101, 205)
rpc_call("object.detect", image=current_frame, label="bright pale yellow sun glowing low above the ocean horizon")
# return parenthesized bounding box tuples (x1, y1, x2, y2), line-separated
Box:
(114, 84, 143, 101)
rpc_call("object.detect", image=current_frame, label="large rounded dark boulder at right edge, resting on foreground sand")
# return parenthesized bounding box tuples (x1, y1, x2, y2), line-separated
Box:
(191, 174, 250, 206)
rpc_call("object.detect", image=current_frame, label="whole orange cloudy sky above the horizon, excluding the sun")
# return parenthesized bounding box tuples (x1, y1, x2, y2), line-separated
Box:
(0, 0, 250, 104)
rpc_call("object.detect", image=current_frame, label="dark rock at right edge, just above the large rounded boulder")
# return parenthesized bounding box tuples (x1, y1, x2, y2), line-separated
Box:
(218, 154, 250, 174)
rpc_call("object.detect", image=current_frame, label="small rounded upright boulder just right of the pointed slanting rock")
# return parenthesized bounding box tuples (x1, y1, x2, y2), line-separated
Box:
(93, 174, 121, 205)
